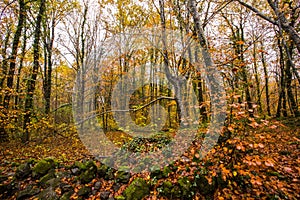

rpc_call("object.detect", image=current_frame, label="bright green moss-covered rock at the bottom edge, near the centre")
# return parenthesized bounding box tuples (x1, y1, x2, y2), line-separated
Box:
(123, 178, 150, 200)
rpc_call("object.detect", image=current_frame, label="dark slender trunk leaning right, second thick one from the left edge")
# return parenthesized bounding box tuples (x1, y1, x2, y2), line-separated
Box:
(23, 0, 46, 142)
